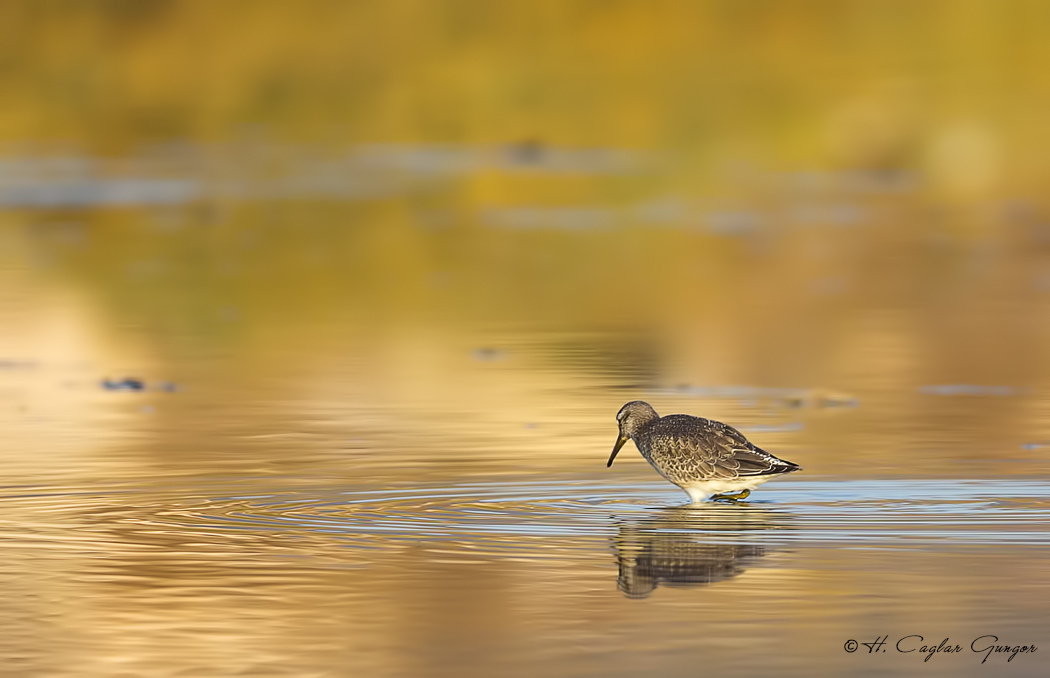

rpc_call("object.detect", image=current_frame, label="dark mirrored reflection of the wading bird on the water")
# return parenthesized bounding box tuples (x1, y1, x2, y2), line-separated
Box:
(613, 505, 788, 598)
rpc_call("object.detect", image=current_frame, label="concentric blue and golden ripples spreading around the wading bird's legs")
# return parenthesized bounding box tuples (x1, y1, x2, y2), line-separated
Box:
(133, 480, 1050, 545)
